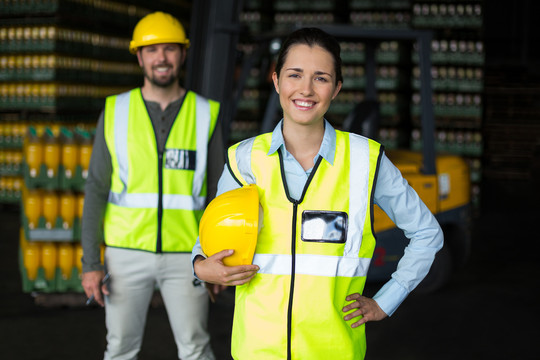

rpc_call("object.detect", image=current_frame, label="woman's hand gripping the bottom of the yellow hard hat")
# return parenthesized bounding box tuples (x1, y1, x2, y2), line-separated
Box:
(193, 250, 259, 286)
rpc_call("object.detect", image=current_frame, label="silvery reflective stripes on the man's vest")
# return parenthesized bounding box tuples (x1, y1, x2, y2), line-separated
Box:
(109, 92, 210, 210)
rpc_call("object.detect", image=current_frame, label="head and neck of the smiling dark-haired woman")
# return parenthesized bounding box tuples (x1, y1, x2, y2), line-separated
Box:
(272, 29, 343, 170)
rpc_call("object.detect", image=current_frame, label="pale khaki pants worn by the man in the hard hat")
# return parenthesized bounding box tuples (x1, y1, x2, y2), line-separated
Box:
(105, 247, 214, 360)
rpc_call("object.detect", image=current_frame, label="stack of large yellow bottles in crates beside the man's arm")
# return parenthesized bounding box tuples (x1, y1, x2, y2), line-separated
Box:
(16, 123, 96, 293)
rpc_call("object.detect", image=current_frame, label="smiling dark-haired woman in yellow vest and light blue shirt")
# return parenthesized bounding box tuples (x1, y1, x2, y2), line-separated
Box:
(193, 28, 443, 359)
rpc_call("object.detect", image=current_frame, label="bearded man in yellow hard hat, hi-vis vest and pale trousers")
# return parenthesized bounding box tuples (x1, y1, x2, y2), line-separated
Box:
(81, 12, 224, 360)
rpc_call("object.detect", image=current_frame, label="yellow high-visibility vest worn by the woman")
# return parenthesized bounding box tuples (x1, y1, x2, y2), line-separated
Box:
(228, 131, 382, 360)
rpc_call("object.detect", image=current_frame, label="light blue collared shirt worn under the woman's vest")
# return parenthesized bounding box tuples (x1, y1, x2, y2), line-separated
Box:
(192, 120, 443, 316)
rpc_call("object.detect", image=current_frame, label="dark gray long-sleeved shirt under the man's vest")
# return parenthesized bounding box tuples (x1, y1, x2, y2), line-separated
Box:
(81, 93, 225, 272)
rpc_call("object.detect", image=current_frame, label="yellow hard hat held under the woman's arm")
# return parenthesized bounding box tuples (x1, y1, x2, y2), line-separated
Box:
(199, 184, 262, 266)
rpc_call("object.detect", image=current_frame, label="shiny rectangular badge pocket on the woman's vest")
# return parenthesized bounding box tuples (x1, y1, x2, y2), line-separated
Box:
(302, 210, 349, 244)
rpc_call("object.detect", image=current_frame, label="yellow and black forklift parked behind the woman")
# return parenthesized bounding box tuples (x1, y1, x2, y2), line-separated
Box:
(186, 0, 471, 293)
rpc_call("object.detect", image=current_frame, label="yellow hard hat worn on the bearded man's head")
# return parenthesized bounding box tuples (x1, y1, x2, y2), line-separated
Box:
(129, 11, 189, 54)
